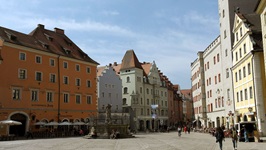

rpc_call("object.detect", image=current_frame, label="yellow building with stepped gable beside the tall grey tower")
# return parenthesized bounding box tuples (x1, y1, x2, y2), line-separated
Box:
(232, 12, 265, 137)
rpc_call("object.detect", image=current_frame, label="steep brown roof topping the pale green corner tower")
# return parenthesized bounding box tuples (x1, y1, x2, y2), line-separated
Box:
(120, 50, 142, 70)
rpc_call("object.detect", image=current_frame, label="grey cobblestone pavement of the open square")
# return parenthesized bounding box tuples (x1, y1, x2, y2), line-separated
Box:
(0, 132, 266, 150)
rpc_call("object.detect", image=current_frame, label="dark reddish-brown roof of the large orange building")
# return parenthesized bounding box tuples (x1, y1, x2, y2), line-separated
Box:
(0, 24, 98, 65)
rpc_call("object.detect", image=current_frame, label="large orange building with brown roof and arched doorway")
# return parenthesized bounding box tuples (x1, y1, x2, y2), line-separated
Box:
(0, 25, 98, 136)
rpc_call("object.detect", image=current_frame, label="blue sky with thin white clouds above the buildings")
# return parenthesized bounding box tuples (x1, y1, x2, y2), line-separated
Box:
(0, 0, 220, 89)
